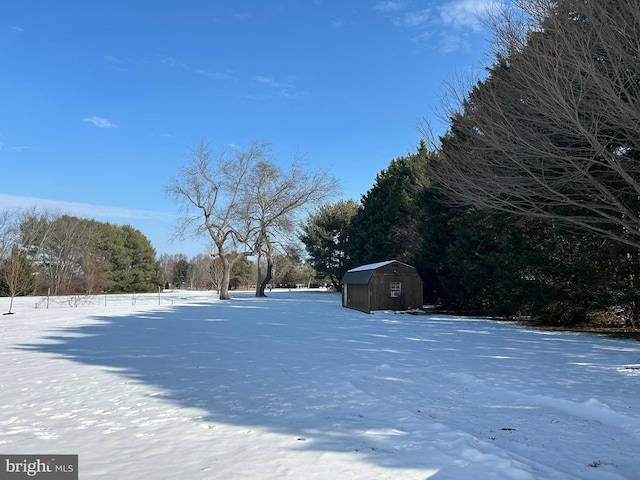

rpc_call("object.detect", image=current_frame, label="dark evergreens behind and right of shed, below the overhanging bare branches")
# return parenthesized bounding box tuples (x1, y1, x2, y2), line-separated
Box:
(301, 145, 640, 325)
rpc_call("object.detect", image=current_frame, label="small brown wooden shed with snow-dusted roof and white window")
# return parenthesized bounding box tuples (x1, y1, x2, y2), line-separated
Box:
(342, 260, 422, 313)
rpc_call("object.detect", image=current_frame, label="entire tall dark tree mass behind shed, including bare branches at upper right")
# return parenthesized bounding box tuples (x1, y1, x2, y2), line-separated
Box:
(302, 0, 640, 326)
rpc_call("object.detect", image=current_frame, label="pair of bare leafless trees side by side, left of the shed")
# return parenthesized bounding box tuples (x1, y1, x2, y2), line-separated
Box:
(166, 143, 338, 299)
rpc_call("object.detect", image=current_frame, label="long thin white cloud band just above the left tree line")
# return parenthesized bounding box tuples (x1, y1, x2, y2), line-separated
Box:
(0, 193, 167, 220)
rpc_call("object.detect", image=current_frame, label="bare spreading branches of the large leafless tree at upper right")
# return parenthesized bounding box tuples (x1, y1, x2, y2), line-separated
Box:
(429, 0, 640, 247)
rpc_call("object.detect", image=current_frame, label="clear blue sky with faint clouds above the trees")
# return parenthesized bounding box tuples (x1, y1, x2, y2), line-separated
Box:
(0, 0, 493, 256)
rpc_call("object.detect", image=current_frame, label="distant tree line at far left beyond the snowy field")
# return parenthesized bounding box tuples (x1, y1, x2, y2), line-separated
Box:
(0, 210, 162, 304)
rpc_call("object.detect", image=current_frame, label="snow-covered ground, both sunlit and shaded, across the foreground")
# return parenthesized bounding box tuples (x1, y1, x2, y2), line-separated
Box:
(0, 291, 640, 480)
